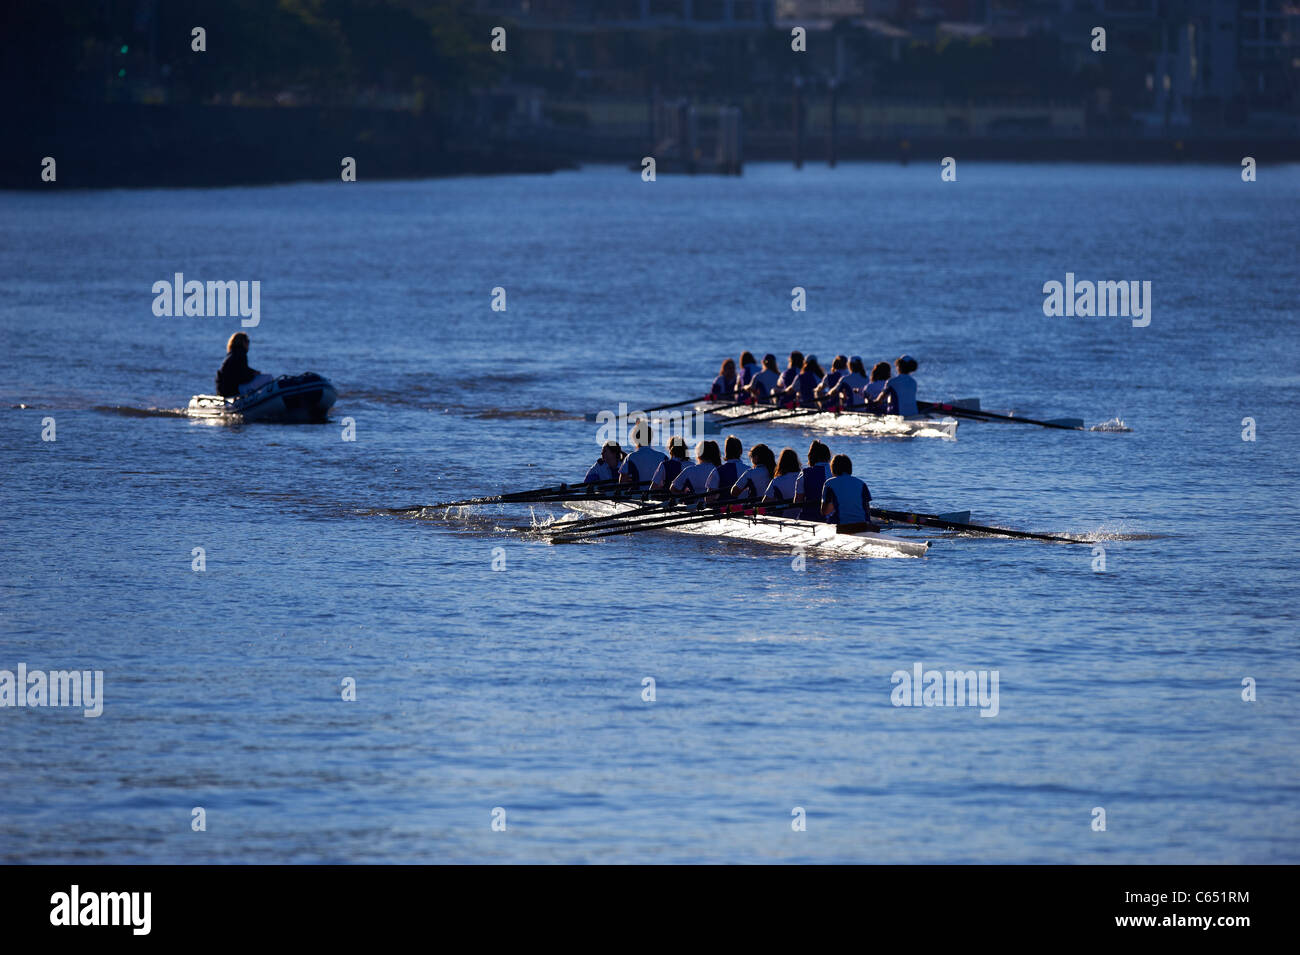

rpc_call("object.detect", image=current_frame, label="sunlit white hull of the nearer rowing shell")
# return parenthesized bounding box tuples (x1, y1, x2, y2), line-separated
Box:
(560, 500, 930, 557)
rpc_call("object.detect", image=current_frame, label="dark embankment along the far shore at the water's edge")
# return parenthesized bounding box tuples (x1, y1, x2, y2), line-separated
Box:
(0, 104, 1300, 190)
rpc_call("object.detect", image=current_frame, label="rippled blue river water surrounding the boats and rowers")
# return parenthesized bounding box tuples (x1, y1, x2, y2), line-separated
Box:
(0, 164, 1300, 863)
